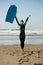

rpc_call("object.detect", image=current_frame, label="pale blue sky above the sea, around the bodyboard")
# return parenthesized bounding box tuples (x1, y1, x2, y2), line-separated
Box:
(0, 0, 43, 30)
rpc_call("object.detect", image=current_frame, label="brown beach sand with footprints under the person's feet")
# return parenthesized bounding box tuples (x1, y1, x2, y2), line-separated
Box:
(0, 45, 43, 65)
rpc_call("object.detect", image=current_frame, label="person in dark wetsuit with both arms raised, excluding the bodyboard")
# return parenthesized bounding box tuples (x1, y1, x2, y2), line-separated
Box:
(15, 15, 30, 51)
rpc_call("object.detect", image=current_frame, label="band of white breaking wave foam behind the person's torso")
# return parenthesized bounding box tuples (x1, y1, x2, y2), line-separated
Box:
(0, 30, 43, 35)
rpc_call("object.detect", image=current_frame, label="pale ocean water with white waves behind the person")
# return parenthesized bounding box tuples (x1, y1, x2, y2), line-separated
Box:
(0, 30, 43, 45)
